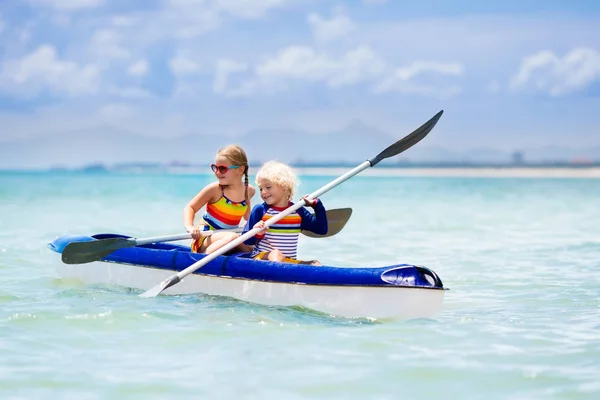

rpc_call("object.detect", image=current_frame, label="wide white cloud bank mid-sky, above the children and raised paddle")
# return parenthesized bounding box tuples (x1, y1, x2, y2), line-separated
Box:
(214, 46, 463, 97)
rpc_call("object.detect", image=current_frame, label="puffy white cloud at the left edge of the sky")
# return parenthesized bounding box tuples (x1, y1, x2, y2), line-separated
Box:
(0, 45, 99, 96)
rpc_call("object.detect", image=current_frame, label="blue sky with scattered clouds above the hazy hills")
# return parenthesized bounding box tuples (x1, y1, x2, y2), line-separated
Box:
(0, 0, 600, 150)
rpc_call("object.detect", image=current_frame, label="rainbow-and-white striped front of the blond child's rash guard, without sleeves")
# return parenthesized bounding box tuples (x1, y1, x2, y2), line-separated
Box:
(251, 203, 302, 259)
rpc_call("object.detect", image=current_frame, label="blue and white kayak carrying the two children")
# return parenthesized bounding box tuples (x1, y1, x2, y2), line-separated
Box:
(48, 233, 448, 320)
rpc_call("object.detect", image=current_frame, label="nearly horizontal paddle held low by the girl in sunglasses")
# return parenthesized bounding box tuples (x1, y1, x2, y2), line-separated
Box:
(61, 208, 352, 264)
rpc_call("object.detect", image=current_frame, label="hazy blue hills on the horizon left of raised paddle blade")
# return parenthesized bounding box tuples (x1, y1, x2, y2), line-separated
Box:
(0, 122, 404, 168)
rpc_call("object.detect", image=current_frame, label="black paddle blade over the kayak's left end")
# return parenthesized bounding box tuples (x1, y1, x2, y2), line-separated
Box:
(61, 238, 135, 264)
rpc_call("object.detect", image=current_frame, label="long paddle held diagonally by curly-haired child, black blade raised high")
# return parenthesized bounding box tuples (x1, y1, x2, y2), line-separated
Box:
(140, 110, 444, 297)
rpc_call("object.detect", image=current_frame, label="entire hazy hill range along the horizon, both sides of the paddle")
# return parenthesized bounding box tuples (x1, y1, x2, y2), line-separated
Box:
(0, 121, 600, 169)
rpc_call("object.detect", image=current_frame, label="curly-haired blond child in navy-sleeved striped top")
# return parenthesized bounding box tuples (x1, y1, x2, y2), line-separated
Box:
(244, 161, 327, 265)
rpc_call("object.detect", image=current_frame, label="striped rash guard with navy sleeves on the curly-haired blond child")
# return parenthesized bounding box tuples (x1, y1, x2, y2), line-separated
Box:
(244, 200, 327, 259)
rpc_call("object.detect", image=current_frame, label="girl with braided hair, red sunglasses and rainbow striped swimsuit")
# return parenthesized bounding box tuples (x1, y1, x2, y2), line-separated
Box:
(183, 145, 255, 254)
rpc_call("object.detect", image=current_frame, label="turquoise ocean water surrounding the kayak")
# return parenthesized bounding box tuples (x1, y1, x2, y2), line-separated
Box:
(0, 172, 600, 399)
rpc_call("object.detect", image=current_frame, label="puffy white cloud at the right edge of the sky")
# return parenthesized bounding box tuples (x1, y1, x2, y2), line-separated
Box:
(510, 47, 600, 96)
